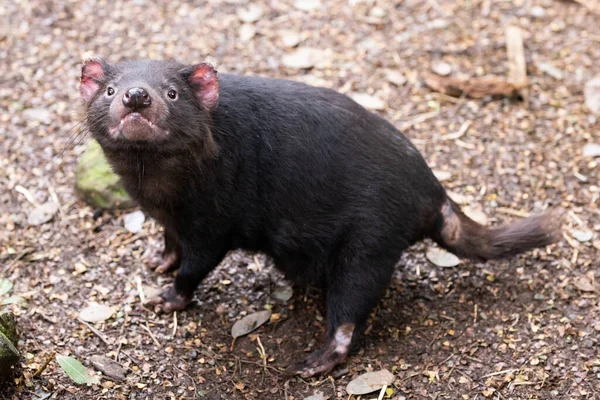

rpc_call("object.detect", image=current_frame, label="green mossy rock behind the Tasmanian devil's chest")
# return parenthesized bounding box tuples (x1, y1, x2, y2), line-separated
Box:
(76, 140, 135, 209)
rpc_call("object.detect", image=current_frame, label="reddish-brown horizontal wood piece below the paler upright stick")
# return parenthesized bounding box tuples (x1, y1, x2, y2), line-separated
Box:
(423, 72, 521, 99)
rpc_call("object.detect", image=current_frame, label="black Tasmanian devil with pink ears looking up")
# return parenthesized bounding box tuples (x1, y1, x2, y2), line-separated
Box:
(80, 58, 560, 377)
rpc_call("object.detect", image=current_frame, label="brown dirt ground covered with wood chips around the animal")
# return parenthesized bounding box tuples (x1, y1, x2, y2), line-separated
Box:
(0, 0, 600, 400)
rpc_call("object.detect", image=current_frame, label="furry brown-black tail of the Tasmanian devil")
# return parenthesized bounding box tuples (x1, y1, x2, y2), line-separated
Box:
(431, 198, 564, 261)
